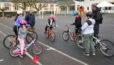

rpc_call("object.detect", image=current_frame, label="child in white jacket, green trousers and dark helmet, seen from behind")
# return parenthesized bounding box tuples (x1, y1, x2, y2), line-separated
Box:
(81, 12, 95, 56)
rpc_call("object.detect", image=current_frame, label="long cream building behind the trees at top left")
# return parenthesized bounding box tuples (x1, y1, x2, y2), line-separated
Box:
(0, 0, 59, 13)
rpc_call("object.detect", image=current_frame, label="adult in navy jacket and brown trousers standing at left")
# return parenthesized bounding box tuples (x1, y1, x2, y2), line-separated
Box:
(25, 10, 35, 31)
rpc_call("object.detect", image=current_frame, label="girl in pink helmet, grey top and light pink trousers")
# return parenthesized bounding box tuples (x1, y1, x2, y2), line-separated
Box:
(18, 20, 27, 57)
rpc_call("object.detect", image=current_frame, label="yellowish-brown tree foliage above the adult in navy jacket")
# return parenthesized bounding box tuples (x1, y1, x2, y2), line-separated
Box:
(11, 0, 53, 14)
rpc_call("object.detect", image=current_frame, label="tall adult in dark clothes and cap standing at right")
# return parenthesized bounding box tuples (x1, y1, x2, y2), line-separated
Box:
(91, 4, 103, 38)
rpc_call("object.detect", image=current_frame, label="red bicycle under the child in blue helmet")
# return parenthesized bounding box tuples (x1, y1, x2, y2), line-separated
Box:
(63, 25, 84, 49)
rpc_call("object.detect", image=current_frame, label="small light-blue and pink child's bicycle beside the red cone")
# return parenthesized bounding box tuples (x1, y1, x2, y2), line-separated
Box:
(10, 39, 43, 57)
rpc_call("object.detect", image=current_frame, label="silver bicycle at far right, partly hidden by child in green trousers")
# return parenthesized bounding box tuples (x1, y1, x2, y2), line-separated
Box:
(76, 35, 114, 57)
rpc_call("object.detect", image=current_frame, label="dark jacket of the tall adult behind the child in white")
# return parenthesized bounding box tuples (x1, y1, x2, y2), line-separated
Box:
(92, 7, 103, 24)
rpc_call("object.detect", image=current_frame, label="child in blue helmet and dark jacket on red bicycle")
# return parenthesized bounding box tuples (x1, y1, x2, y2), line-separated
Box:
(72, 11, 82, 34)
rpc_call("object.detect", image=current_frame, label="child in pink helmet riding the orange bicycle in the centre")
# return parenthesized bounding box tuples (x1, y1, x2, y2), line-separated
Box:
(45, 14, 56, 33)
